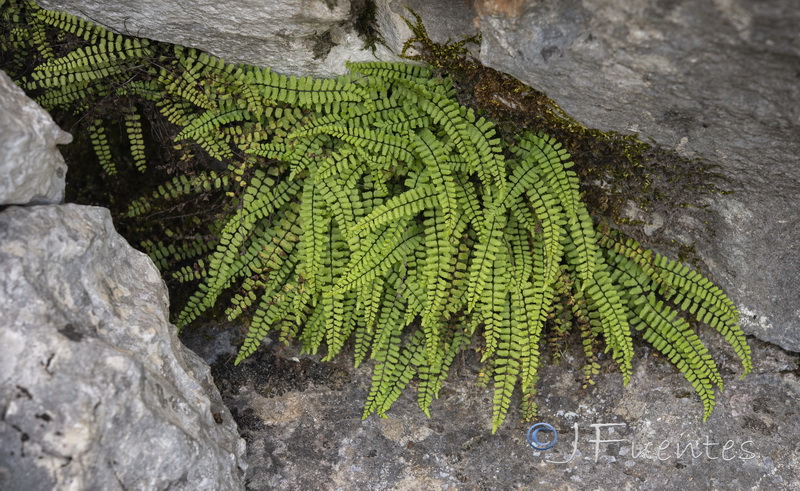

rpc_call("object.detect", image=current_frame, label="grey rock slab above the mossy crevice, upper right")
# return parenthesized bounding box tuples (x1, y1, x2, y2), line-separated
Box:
(476, 0, 800, 351)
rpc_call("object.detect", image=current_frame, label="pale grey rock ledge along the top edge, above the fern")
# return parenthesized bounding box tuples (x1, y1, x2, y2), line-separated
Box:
(38, 0, 391, 77)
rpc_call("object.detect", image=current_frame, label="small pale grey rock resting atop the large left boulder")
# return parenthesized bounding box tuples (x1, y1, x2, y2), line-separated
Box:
(0, 70, 72, 205)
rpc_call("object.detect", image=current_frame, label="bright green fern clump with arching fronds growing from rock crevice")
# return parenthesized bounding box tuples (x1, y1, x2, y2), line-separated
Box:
(1, 1, 752, 432)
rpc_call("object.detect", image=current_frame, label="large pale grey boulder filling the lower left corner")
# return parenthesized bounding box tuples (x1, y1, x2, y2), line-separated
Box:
(0, 205, 244, 490)
